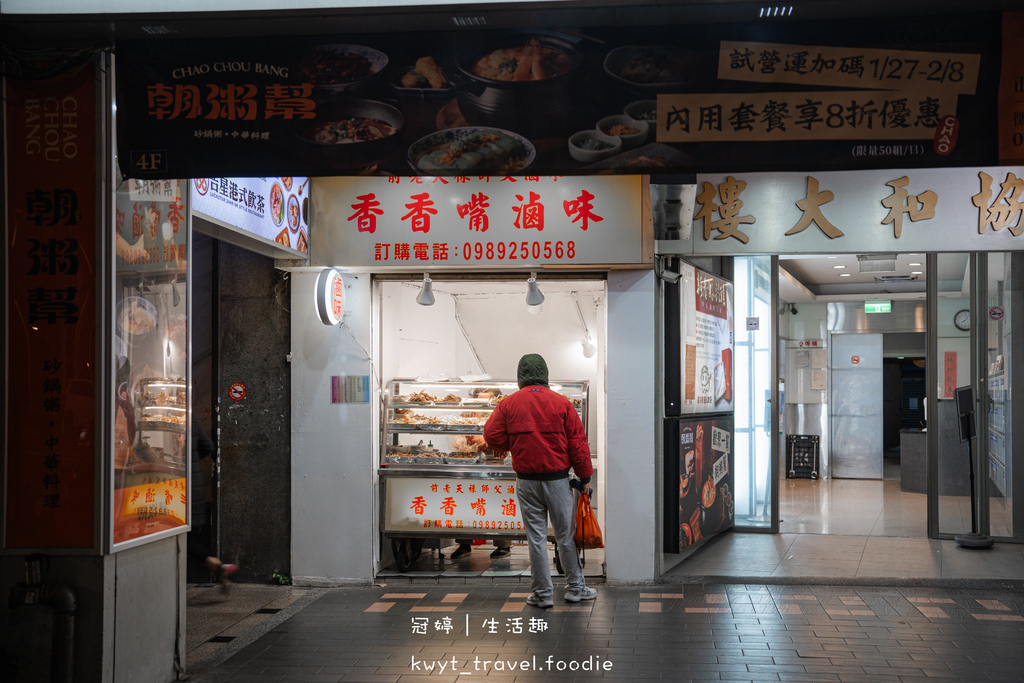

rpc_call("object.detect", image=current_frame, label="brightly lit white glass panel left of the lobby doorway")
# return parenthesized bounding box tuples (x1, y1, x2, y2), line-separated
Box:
(733, 256, 779, 532)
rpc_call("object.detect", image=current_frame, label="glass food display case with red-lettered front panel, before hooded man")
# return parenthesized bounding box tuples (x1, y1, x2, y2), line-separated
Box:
(380, 379, 593, 571)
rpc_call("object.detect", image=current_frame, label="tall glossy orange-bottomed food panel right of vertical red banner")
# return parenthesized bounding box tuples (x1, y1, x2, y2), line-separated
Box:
(110, 180, 190, 547)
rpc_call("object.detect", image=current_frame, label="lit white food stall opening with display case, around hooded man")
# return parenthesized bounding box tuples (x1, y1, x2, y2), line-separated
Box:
(374, 273, 607, 578)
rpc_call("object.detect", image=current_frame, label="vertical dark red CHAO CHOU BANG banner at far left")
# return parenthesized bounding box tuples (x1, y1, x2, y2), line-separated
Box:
(5, 63, 97, 548)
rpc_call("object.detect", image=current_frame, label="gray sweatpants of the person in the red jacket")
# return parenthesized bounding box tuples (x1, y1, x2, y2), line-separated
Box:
(516, 478, 587, 598)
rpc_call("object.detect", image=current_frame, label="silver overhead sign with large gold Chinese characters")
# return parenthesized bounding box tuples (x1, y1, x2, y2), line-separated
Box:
(658, 167, 1024, 254)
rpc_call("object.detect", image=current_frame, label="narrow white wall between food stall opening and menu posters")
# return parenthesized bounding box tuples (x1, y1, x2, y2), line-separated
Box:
(604, 270, 660, 583)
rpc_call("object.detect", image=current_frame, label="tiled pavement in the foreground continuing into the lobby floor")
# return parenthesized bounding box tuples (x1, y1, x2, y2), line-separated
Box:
(187, 466, 1024, 683)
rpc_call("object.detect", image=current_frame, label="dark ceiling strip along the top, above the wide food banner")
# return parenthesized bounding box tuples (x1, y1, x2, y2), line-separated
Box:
(0, 0, 1020, 46)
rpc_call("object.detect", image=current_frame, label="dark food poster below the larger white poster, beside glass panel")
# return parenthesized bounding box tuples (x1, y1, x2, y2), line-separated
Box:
(679, 417, 735, 550)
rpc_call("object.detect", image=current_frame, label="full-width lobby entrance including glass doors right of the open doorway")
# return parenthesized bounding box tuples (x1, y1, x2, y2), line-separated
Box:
(777, 252, 1024, 539)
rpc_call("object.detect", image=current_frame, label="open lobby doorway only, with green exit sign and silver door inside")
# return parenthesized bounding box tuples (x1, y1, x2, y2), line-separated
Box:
(776, 253, 933, 538)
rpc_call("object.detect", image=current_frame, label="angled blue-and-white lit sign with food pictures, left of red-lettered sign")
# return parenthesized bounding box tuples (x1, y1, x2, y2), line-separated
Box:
(191, 176, 310, 254)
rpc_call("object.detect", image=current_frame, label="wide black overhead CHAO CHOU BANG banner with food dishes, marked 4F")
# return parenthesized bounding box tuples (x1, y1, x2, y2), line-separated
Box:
(116, 14, 999, 178)
